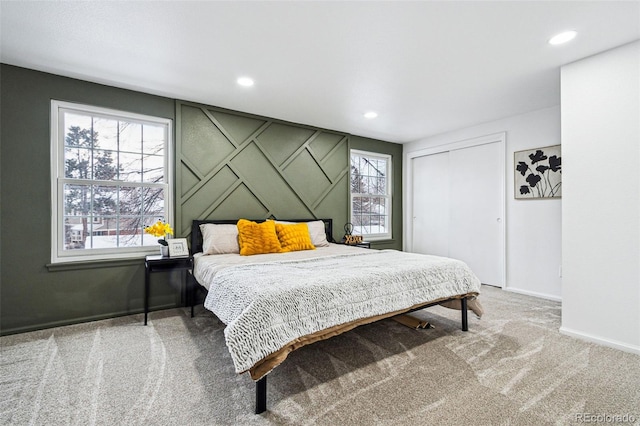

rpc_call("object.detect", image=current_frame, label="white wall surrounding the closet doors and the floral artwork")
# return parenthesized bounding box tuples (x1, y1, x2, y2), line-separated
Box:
(403, 106, 564, 300)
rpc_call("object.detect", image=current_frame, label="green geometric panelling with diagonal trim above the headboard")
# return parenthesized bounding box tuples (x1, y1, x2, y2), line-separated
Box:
(176, 101, 349, 238)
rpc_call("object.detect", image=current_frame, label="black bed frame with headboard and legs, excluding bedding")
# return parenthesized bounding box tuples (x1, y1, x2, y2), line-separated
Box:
(187, 219, 469, 414)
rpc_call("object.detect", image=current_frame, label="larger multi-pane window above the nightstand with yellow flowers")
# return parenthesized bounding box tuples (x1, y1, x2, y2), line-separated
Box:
(51, 101, 173, 263)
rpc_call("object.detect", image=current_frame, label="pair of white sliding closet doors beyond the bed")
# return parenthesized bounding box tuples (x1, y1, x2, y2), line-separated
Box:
(411, 138, 504, 287)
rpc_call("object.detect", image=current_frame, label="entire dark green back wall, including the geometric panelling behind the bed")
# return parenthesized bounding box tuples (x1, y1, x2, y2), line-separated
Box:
(0, 64, 402, 334)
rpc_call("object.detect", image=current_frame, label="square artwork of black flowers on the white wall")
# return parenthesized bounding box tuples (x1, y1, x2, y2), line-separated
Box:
(513, 145, 562, 200)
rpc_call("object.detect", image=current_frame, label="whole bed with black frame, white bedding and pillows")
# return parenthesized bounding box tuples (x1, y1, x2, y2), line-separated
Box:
(189, 219, 482, 413)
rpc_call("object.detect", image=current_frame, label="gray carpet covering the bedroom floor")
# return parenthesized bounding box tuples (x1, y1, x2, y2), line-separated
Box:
(0, 286, 640, 425)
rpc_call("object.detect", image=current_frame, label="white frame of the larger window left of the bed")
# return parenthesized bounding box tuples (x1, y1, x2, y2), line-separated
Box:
(51, 100, 174, 263)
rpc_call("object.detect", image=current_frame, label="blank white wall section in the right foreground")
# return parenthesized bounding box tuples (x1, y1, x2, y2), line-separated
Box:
(560, 42, 640, 353)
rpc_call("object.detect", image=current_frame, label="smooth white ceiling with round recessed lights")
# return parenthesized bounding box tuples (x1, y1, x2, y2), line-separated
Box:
(0, 0, 640, 142)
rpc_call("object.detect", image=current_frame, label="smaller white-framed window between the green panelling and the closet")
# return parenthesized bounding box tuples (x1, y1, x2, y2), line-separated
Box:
(351, 150, 391, 241)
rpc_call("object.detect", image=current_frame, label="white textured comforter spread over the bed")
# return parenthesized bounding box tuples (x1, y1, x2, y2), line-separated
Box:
(200, 248, 480, 373)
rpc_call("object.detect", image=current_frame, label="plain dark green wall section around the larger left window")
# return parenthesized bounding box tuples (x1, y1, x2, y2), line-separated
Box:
(0, 64, 179, 334)
